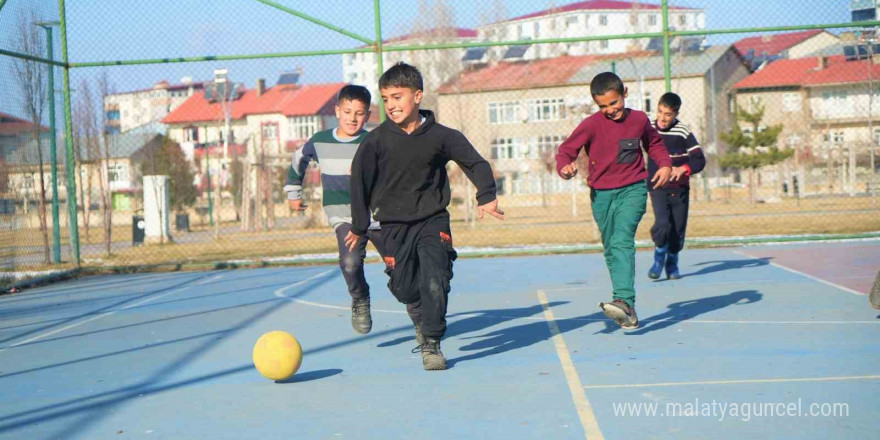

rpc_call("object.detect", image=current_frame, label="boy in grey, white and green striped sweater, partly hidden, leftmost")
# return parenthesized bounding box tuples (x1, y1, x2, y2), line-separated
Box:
(284, 84, 383, 334)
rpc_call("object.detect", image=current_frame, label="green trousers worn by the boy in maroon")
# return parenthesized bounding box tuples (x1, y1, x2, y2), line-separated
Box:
(590, 181, 648, 307)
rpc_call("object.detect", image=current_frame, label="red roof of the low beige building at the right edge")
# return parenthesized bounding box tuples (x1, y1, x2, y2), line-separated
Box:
(734, 55, 880, 89)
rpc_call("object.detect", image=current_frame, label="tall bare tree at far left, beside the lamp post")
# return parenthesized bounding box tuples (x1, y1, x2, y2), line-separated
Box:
(13, 10, 51, 264)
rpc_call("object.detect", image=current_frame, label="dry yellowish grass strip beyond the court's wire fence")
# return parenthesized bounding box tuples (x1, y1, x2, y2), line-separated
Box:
(6, 193, 880, 270)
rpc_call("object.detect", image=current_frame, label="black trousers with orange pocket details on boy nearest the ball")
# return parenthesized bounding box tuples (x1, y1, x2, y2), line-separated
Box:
(380, 212, 457, 339)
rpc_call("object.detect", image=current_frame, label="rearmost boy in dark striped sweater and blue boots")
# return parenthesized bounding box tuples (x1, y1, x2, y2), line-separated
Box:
(648, 92, 706, 280)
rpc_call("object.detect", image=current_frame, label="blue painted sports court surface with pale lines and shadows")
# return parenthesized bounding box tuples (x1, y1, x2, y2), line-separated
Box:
(0, 240, 880, 440)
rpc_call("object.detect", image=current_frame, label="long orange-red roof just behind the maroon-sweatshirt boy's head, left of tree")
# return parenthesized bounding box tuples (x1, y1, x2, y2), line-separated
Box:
(437, 52, 654, 94)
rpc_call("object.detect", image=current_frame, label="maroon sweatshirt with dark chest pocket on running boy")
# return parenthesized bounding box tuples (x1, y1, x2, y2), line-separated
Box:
(556, 109, 672, 189)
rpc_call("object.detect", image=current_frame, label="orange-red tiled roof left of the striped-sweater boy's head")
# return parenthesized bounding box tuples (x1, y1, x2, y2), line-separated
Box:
(162, 83, 345, 124)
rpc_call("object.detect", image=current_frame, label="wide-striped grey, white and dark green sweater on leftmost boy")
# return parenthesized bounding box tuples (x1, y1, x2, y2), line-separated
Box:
(284, 129, 367, 229)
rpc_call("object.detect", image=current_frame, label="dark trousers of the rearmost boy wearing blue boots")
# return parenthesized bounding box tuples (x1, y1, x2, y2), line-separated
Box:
(651, 188, 690, 254)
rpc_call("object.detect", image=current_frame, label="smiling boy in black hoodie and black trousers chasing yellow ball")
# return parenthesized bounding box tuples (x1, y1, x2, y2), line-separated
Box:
(345, 63, 504, 370)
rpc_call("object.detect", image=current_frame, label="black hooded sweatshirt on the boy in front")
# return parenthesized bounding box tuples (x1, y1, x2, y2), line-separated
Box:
(351, 110, 495, 235)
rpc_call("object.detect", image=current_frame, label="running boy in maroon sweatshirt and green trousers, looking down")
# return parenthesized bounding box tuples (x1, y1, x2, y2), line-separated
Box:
(556, 72, 672, 329)
